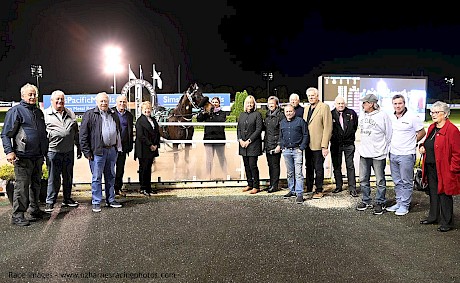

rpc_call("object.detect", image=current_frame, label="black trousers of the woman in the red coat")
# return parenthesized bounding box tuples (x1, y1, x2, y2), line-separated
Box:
(425, 163, 454, 228)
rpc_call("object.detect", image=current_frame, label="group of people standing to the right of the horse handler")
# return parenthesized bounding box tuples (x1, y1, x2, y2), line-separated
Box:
(237, 87, 460, 232)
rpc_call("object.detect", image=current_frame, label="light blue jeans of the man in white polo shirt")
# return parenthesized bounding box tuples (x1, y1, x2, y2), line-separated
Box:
(390, 153, 415, 209)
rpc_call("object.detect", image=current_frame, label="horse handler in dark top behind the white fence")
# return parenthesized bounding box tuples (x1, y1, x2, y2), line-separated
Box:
(196, 96, 227, 180)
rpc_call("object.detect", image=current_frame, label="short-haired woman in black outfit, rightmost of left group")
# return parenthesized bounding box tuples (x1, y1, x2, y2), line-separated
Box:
(134, 101, 160, 196)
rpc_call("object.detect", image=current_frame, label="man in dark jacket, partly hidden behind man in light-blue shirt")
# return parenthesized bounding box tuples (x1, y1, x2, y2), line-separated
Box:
(112, 95, 134, 195)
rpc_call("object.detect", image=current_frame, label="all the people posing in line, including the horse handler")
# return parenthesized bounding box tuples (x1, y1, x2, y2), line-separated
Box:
(1, 84, 460, 232)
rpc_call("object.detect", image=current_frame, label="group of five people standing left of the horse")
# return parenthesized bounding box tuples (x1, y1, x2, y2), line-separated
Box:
(1, 83, 160, 226)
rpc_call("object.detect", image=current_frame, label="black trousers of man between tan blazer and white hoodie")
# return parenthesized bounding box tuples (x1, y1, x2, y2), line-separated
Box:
(331, 144, 356, 191)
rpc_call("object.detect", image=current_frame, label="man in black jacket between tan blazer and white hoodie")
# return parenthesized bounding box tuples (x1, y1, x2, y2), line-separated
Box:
(331, 96, 358, 197)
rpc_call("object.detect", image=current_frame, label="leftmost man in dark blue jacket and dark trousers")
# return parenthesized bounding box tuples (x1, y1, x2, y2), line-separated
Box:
(1, 84, 48, 226)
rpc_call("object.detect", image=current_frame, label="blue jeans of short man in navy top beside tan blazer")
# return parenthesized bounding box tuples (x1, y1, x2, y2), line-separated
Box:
(283, 148, 303, 196)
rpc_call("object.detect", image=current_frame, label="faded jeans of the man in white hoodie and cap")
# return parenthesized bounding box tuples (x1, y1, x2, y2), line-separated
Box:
(359, 157, 387, 205)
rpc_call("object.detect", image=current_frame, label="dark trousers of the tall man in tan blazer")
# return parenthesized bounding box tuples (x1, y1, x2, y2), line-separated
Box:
(305, 147, 324, 193)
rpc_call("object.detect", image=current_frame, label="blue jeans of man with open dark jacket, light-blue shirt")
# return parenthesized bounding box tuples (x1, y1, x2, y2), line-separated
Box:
(89, 147, 118, 204)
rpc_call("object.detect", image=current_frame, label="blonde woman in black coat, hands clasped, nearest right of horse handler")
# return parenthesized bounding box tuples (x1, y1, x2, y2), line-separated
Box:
(237, 95, 264, 194)
